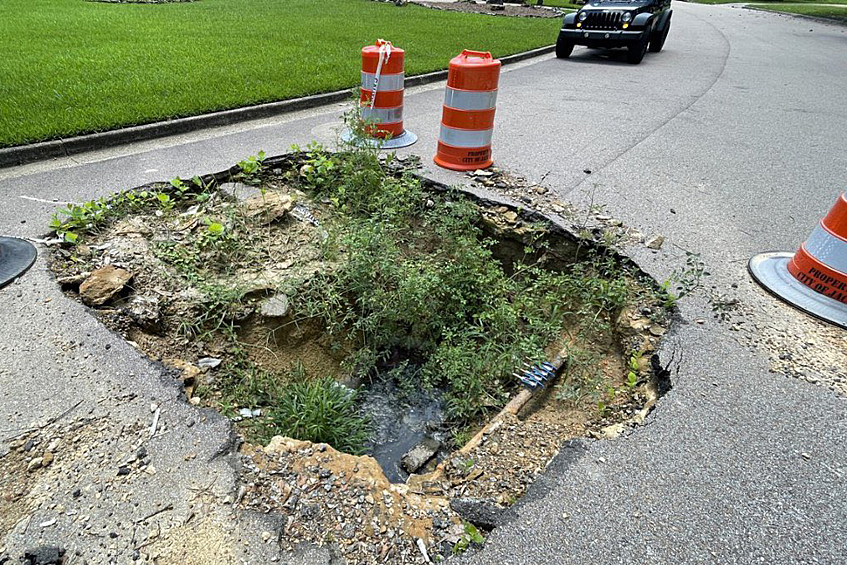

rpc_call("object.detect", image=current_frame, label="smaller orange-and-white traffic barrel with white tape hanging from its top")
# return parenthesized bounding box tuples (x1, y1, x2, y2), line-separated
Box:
(343, 39, 418, 149)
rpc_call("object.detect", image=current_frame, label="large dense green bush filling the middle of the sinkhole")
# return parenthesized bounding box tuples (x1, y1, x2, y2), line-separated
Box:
(293, 107, 652, 422)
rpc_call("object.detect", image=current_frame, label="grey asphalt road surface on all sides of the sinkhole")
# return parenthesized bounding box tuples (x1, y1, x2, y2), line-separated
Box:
(0, 3, 847, 564)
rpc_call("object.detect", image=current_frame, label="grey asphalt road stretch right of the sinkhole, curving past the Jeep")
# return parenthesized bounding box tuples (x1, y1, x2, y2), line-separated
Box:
(469, 2, 847, 564)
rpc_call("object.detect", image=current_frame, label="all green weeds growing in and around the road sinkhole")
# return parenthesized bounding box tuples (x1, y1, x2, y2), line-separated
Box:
(51, 104, 668, 450)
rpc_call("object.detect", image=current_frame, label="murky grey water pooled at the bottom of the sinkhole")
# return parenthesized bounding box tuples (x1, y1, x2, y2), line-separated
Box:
(360, 379, 447, 483)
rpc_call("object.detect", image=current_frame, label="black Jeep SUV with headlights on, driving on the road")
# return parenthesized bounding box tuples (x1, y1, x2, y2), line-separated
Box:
(556, 0, 673, 65)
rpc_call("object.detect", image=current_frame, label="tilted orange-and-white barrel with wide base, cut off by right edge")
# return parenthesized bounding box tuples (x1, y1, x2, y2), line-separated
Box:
(748, 193, 847, 328)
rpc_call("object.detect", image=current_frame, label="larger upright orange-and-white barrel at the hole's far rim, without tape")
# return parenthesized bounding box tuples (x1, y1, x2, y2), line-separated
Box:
(435, 49, 501, 171)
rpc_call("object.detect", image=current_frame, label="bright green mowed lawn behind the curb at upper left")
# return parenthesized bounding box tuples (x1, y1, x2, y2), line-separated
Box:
(0, 0, 559, 146)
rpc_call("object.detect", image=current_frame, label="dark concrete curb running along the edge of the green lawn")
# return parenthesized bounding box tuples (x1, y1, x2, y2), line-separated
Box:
(0, 45, 555, 168)
